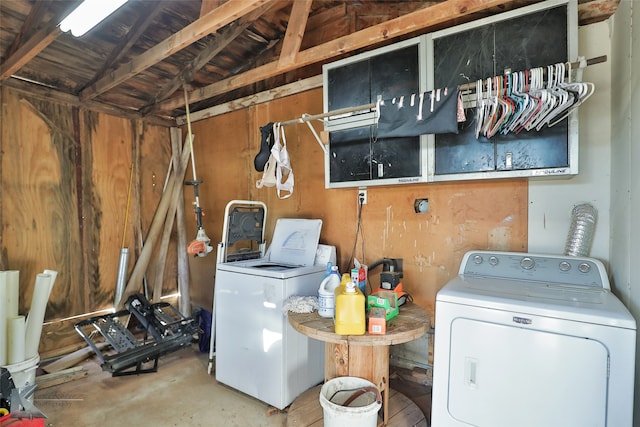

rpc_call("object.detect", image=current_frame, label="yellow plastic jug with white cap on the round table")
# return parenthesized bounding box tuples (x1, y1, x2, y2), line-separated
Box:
(335, 280, 367, 335)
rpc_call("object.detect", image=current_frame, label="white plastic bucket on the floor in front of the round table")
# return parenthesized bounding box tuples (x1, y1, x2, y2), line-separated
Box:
(320, 377, 382, 427)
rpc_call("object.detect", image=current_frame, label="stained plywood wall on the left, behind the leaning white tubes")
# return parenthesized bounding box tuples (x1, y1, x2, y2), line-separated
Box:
(0, 88, 176, 354)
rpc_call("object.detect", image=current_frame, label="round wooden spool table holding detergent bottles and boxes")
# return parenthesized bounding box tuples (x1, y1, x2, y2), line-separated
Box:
(288, 302, 430, 425)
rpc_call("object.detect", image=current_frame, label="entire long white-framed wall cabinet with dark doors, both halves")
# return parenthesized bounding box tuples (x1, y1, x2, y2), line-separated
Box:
(323, 0, 578, 188)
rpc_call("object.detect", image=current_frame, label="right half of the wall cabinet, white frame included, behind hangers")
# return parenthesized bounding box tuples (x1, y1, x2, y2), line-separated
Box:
(426, 2, 578, 181)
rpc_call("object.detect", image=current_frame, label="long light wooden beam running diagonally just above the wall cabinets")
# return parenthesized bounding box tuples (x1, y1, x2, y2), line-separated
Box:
(157, 0, 517, 111)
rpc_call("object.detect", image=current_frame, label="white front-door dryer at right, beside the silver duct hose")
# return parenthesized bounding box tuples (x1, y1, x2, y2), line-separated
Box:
(431, 251, 636, 427)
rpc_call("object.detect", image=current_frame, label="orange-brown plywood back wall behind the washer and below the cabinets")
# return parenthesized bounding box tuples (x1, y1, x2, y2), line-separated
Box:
(187, 89, 528, 320)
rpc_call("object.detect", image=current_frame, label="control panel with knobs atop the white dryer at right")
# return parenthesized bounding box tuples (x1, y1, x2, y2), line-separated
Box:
(459, 251, 610, 289)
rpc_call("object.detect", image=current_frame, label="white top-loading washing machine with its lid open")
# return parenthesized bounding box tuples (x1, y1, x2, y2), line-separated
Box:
(214, 219, 327, 409)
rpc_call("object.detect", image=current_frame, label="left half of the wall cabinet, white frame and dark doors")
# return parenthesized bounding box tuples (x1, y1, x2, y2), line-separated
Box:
(324, 38, 427, 188)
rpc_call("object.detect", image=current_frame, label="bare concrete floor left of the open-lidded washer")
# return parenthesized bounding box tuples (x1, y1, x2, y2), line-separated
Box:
(33, 346, 287, 427)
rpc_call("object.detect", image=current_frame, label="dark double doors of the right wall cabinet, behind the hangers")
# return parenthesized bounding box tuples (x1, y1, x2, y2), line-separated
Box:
(433, 6, 569, 175)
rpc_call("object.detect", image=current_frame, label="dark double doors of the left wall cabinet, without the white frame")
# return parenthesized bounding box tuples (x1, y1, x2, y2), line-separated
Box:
(328, 44, 422, 185)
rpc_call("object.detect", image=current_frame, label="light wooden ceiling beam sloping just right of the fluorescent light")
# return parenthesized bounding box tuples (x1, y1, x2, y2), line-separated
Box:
(80, 0, 271, 101)
